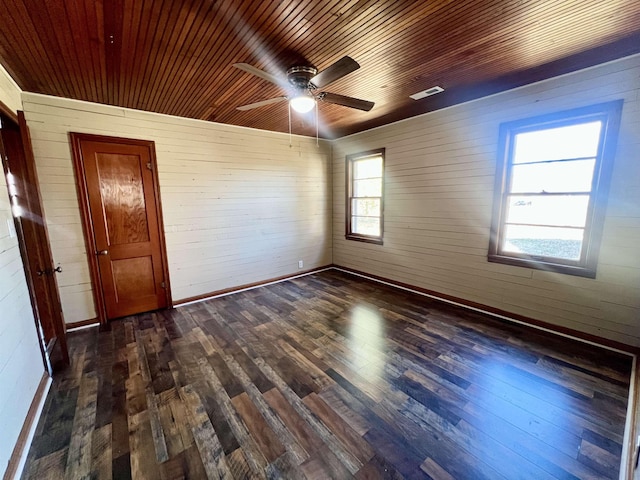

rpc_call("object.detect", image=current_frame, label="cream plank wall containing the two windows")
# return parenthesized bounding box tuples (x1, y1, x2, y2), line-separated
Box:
(333, 55, 640, 346)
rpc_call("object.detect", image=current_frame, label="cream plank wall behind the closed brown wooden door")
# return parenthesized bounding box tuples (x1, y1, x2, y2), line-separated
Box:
(23, 93, 332, 323)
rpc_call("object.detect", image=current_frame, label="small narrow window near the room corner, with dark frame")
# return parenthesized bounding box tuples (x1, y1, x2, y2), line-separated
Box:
(346, 148, 384, 245)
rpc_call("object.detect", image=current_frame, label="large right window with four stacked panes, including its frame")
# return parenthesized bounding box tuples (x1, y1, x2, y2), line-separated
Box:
(488, 100, 622, 278)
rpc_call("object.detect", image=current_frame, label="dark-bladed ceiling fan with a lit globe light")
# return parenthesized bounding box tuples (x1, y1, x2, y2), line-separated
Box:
(233, 56, 374, 113)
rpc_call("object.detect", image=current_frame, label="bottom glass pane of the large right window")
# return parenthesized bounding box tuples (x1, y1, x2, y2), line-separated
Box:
(502, 225, 584, 260)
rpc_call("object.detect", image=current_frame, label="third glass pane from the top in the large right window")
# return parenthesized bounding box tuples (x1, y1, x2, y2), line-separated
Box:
(506, 195, 589, 227)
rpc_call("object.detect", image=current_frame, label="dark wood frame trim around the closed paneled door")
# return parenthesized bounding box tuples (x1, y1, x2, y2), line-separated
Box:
(69, 132, 172, 325)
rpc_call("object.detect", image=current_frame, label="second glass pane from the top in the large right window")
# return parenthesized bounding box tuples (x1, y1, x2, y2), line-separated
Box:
(511, 159, 596, 193)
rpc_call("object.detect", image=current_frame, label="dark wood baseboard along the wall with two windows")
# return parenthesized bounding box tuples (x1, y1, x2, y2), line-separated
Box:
(332, 265, 640, 355)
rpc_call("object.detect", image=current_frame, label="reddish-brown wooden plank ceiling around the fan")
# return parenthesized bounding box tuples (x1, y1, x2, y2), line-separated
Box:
(0, 0, 640, 138)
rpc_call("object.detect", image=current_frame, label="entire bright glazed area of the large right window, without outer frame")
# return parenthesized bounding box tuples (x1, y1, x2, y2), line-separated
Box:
(502, 121, 602, 260)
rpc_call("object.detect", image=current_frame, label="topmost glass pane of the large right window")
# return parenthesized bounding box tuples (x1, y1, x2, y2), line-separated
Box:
(513, 121, 602, 163)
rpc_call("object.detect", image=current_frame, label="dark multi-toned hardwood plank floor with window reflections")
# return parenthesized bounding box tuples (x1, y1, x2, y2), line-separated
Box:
(23, 270, 631, 480)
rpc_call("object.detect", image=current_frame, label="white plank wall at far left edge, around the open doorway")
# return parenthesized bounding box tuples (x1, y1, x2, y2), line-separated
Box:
(0, 66, 44, 477)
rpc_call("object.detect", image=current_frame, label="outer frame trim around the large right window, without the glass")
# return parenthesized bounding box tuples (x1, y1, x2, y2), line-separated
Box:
(487, 100, 623, 278)
